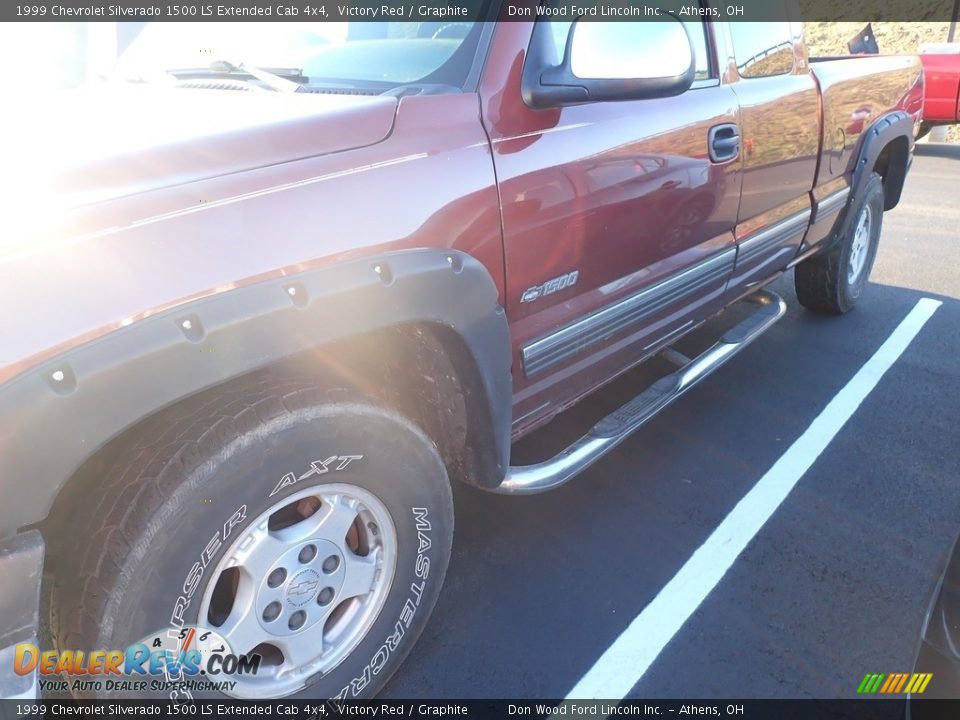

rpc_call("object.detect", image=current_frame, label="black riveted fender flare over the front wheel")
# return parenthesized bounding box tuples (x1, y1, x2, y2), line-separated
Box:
(0, 249, 512, 538)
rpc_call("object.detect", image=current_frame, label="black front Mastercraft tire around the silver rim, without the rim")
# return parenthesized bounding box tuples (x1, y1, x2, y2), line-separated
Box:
(50, 374, 453, 699)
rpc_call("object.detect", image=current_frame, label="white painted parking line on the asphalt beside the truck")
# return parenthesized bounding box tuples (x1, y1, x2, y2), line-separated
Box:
(566, 298, 942, 700)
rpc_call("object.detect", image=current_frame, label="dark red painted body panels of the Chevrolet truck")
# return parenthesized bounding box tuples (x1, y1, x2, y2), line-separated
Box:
(0, 22, 928, 435)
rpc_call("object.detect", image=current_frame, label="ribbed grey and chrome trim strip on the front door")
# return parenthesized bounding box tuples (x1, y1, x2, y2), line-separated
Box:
(520, 247, 737, 377)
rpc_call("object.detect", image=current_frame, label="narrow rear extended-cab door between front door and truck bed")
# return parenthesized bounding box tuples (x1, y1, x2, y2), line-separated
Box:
(724, 22, 820, 294)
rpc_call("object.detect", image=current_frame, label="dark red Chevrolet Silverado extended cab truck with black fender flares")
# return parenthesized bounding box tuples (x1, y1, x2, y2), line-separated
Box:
(0, 12, 923, 698)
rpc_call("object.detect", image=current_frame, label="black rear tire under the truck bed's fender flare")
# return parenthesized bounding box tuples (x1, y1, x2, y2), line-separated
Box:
(794, 173, 884, 315)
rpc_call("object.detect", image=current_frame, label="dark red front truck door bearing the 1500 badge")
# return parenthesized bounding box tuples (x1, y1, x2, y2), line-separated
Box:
(480, 20, 741, 431)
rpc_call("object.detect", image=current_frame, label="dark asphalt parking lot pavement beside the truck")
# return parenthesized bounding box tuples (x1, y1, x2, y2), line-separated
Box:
(384, 145, 960, 699)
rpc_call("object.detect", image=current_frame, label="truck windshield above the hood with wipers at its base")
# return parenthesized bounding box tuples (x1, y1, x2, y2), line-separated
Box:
(113, 22, 488, 88)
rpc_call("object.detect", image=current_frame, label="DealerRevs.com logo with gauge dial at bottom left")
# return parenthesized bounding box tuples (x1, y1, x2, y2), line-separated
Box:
(13, 626, 261, 692)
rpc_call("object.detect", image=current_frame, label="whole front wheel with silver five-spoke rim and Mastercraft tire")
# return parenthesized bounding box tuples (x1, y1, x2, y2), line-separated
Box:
(51, 380, 453, 698)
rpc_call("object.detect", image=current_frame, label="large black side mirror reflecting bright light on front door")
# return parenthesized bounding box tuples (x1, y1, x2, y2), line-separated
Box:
(522, 15, 696, 108)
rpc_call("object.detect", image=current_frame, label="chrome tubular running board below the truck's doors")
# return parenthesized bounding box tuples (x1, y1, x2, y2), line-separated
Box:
(491, 290, 787, 495)
